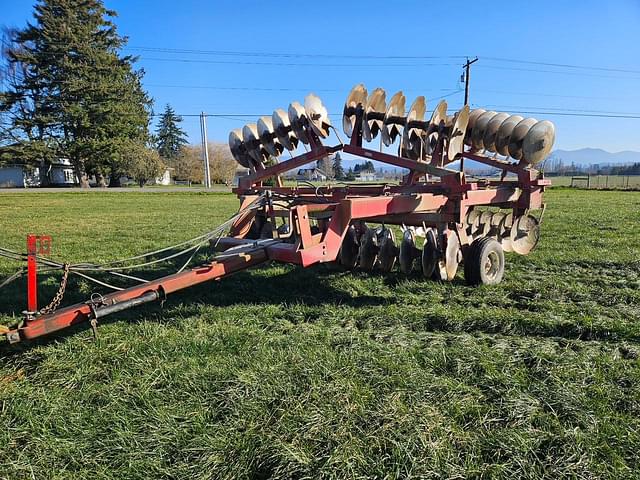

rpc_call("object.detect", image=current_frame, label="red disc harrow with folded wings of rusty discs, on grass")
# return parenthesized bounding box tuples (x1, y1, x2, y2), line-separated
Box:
(5, 84, 555, 342)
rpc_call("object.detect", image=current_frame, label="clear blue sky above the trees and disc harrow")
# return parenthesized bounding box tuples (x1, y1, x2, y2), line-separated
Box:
(0, 0, 640, 151)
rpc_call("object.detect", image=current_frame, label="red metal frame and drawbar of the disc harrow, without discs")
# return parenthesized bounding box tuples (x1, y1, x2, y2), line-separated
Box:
(7, 108, 550, 342)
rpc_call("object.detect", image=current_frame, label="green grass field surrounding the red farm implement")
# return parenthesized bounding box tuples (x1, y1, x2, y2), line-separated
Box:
(0, 189, 640, 479)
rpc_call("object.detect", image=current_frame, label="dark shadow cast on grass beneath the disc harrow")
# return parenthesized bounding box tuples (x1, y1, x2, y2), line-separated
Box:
(0, 255, 640, 360)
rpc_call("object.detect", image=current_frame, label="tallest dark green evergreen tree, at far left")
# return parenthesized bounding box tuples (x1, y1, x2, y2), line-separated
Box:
(0, 0, 151, 186)
